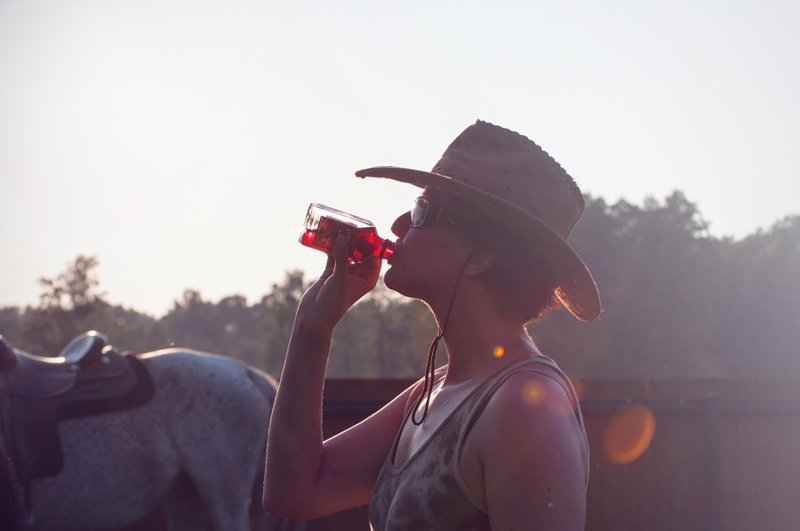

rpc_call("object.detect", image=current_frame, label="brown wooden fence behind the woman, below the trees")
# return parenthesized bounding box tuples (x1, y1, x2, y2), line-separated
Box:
(298, 380, 800, 531)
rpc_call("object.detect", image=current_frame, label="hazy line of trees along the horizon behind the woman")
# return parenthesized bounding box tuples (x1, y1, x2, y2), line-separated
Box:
(0, 191, 800, 379)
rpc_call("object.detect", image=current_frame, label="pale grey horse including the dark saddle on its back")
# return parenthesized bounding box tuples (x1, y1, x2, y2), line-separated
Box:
(0, 331, 292, 531)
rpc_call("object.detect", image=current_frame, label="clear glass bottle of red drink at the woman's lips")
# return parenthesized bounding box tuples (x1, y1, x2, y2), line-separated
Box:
(300, 207, 394, 262)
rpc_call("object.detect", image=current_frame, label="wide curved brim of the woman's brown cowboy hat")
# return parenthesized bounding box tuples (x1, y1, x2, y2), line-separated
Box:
(356, 166, 601, 321)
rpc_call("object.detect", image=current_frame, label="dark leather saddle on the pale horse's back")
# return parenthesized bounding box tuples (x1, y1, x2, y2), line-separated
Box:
(0, 331, 154, 483)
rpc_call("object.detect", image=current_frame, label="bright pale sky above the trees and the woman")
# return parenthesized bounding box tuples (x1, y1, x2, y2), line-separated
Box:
(0, 0, 800, 316)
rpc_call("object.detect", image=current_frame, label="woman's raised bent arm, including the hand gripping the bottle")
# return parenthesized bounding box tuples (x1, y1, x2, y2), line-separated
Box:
(262, 237, 407, 518)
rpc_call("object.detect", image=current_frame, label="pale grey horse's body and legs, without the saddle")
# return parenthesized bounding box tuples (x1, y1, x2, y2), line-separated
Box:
(0, 332, 287, 531)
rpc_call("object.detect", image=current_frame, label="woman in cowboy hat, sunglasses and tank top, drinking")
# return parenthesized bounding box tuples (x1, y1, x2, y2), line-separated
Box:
(263, 121, 600, 531)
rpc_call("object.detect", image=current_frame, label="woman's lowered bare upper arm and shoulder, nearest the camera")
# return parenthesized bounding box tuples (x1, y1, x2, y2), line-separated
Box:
(470, 372, 586, 531)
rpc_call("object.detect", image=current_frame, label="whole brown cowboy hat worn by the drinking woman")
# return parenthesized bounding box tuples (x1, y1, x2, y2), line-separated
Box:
(356, 120, 600, 321)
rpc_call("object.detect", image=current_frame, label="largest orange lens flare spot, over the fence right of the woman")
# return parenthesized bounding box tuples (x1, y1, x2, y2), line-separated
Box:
(604, 405, 656, 465)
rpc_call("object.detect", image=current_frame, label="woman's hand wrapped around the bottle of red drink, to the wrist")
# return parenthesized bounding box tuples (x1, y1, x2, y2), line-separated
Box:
(297, 233, 381, 331)
